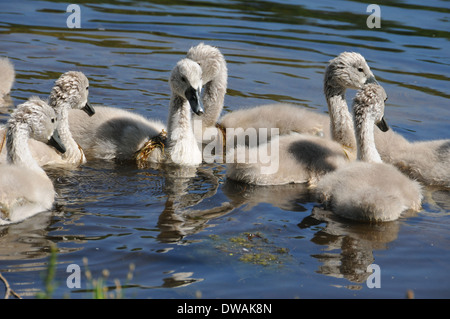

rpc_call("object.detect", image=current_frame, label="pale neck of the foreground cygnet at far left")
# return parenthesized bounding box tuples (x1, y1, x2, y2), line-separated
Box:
(6, 123, 45, 174)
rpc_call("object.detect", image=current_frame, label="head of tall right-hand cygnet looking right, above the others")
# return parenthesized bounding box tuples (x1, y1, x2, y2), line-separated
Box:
(325, 52, 377, 90)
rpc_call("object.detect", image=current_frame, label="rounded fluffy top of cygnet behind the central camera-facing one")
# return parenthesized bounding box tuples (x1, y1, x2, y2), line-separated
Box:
(186, 43, 228, 84)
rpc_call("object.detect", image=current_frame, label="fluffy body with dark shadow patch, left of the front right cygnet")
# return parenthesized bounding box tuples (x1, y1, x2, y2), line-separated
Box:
(226, 134, 349, 185)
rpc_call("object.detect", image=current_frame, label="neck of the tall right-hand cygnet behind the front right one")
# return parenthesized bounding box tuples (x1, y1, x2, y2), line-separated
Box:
(325, 82, 356, 148)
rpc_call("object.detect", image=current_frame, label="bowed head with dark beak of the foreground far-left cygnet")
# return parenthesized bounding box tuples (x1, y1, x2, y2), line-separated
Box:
(8, 96, 66, 153)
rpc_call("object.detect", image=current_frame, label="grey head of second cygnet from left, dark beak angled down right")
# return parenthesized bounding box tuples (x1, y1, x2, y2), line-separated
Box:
(50, 71, 95, 116)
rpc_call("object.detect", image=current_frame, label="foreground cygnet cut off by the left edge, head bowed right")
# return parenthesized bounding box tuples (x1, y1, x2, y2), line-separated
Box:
(0, 97, 64, 225)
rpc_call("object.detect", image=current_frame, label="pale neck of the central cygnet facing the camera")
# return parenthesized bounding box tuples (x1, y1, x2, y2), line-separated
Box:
(167, 94, 201, 164)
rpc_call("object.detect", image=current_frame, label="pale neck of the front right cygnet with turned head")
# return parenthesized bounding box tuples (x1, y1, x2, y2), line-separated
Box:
(355, 114, 382, 163)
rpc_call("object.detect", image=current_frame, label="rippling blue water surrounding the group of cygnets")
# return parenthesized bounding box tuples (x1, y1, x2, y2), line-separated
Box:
(0, 0, 450, 299)
